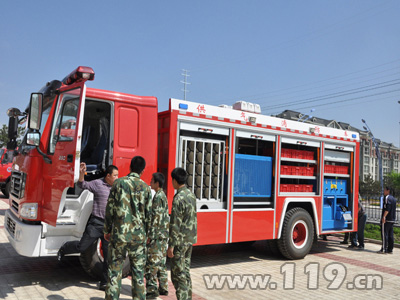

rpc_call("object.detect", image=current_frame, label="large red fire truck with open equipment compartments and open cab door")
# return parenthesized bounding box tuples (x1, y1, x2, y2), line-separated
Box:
(5, 67, 359, 278)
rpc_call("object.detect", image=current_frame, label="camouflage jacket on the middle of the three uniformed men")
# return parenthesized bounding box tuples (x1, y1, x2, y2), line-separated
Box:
(149, 189, 169, 240)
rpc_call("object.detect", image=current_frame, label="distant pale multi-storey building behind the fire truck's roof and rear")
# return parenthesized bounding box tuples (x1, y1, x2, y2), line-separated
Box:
(276, 110, 400, 181)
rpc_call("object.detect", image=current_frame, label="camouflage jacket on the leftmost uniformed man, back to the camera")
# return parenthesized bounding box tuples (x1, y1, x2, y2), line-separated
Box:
(104, 173, 152, 243)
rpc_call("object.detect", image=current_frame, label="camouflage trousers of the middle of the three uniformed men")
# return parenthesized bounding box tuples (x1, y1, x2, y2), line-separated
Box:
(145, 239, 168, 296)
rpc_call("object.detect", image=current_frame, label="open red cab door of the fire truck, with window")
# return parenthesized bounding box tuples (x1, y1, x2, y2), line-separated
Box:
(41, 83, 86, 226)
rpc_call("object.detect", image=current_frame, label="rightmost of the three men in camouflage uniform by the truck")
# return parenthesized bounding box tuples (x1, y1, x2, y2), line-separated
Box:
(167, 168, 197, 300)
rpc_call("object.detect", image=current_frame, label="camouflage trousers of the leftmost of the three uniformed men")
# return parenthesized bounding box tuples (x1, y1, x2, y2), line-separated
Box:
(105, 242, 146, 300)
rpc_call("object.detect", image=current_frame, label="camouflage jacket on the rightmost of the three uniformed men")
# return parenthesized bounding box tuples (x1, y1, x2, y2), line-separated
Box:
(168, 186, 197, 247)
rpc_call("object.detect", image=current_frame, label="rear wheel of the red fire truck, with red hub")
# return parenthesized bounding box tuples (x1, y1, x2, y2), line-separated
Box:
(278, 207, 314, 259)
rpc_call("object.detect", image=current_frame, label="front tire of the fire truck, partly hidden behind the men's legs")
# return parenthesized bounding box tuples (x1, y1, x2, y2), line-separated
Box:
(79, 239, 131, 280)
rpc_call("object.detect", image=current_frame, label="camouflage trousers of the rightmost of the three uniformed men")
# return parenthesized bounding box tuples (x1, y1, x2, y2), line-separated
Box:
(171, 245, 193, 300)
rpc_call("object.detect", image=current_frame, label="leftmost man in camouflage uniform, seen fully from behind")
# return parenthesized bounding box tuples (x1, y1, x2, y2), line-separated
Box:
(104, 156, 152, 300)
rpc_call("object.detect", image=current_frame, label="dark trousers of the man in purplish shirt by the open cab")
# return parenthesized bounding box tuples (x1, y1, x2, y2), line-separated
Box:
(61, 216, 108, 284)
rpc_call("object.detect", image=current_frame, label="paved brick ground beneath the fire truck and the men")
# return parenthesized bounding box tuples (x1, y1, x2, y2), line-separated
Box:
(0, 198, 400, 300)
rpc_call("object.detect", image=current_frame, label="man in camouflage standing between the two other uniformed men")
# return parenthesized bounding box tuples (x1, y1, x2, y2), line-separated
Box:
(145, 173, 169, 299)
